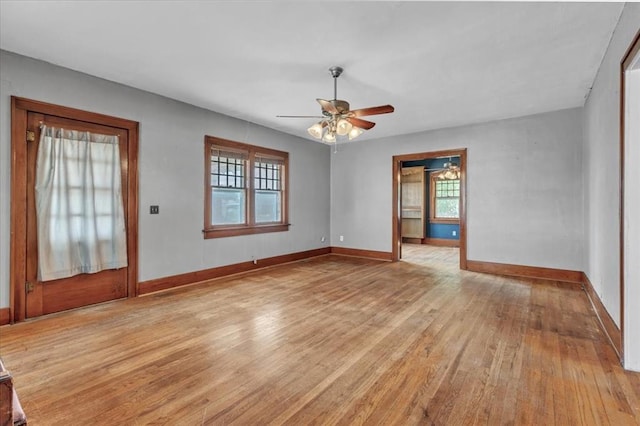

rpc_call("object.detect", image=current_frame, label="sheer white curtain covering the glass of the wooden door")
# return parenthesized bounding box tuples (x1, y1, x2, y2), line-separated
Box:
(35, 126, 127, 281)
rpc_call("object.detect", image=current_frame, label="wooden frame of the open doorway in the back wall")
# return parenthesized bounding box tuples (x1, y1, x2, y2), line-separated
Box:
(391, 148, 467, 269)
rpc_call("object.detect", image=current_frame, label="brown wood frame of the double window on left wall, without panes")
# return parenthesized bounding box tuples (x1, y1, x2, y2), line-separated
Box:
(202, 135, 289, 239)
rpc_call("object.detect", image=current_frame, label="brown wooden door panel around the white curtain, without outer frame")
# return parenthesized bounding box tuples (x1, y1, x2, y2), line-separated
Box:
(25, 112, 131, 318)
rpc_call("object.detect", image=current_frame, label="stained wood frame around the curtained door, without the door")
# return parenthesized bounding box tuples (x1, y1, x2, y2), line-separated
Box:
(9, 96, 139, 323)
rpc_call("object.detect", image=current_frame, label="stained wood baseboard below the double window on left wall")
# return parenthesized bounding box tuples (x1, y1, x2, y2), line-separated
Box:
(138, 247, 331, 295)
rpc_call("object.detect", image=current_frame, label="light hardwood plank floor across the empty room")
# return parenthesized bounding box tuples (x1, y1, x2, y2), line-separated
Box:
(0, 245, 640, 426)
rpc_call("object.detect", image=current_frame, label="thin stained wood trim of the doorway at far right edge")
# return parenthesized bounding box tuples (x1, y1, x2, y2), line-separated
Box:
(617, 30, 640, 361)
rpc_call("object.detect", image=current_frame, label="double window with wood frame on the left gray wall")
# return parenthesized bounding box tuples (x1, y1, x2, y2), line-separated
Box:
(204, 136, 289, 238)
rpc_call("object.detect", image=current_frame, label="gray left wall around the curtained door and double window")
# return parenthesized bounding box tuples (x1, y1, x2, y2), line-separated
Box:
(0, 51, 330, 307)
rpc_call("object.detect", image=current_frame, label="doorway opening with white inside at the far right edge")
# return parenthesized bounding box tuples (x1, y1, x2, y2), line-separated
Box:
(620, 33, 640, 371)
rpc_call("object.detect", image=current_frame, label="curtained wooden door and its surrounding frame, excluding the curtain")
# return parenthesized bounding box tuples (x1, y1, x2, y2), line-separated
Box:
(10, 97, 138, 322)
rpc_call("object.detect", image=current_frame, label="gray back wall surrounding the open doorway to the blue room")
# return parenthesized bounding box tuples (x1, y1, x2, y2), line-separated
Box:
(331, 108, 584, 271)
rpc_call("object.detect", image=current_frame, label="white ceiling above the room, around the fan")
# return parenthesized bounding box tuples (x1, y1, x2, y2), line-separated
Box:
(0, 0, 624, 144)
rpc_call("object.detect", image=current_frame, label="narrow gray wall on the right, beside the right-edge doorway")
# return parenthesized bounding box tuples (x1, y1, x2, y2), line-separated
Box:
(583, 3, 640, 365)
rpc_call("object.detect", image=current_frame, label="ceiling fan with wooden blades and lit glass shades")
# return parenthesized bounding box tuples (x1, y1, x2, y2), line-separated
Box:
(277, 67, 394, 143)
